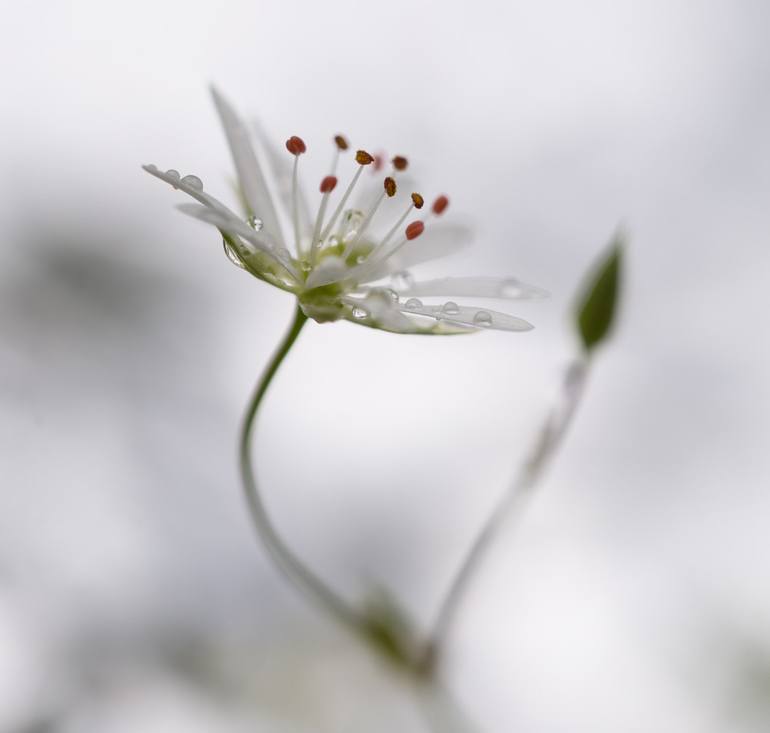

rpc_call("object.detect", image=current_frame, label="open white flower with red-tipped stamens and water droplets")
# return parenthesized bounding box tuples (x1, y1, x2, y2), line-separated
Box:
(144, 90, 543, 334)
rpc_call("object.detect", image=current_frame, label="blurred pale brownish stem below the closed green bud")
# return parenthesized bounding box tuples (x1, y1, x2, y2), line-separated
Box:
(421, 359, 588, 670)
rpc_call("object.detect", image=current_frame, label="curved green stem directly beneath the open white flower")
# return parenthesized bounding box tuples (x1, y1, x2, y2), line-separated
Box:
(239, 305, 362, 633)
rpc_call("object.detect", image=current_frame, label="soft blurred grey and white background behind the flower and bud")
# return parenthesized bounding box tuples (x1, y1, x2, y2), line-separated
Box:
(0, 0, 770, 733)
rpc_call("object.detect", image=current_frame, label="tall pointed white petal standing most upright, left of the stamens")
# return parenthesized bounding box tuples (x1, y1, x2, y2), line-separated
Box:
(211, 87, 284, 246)
